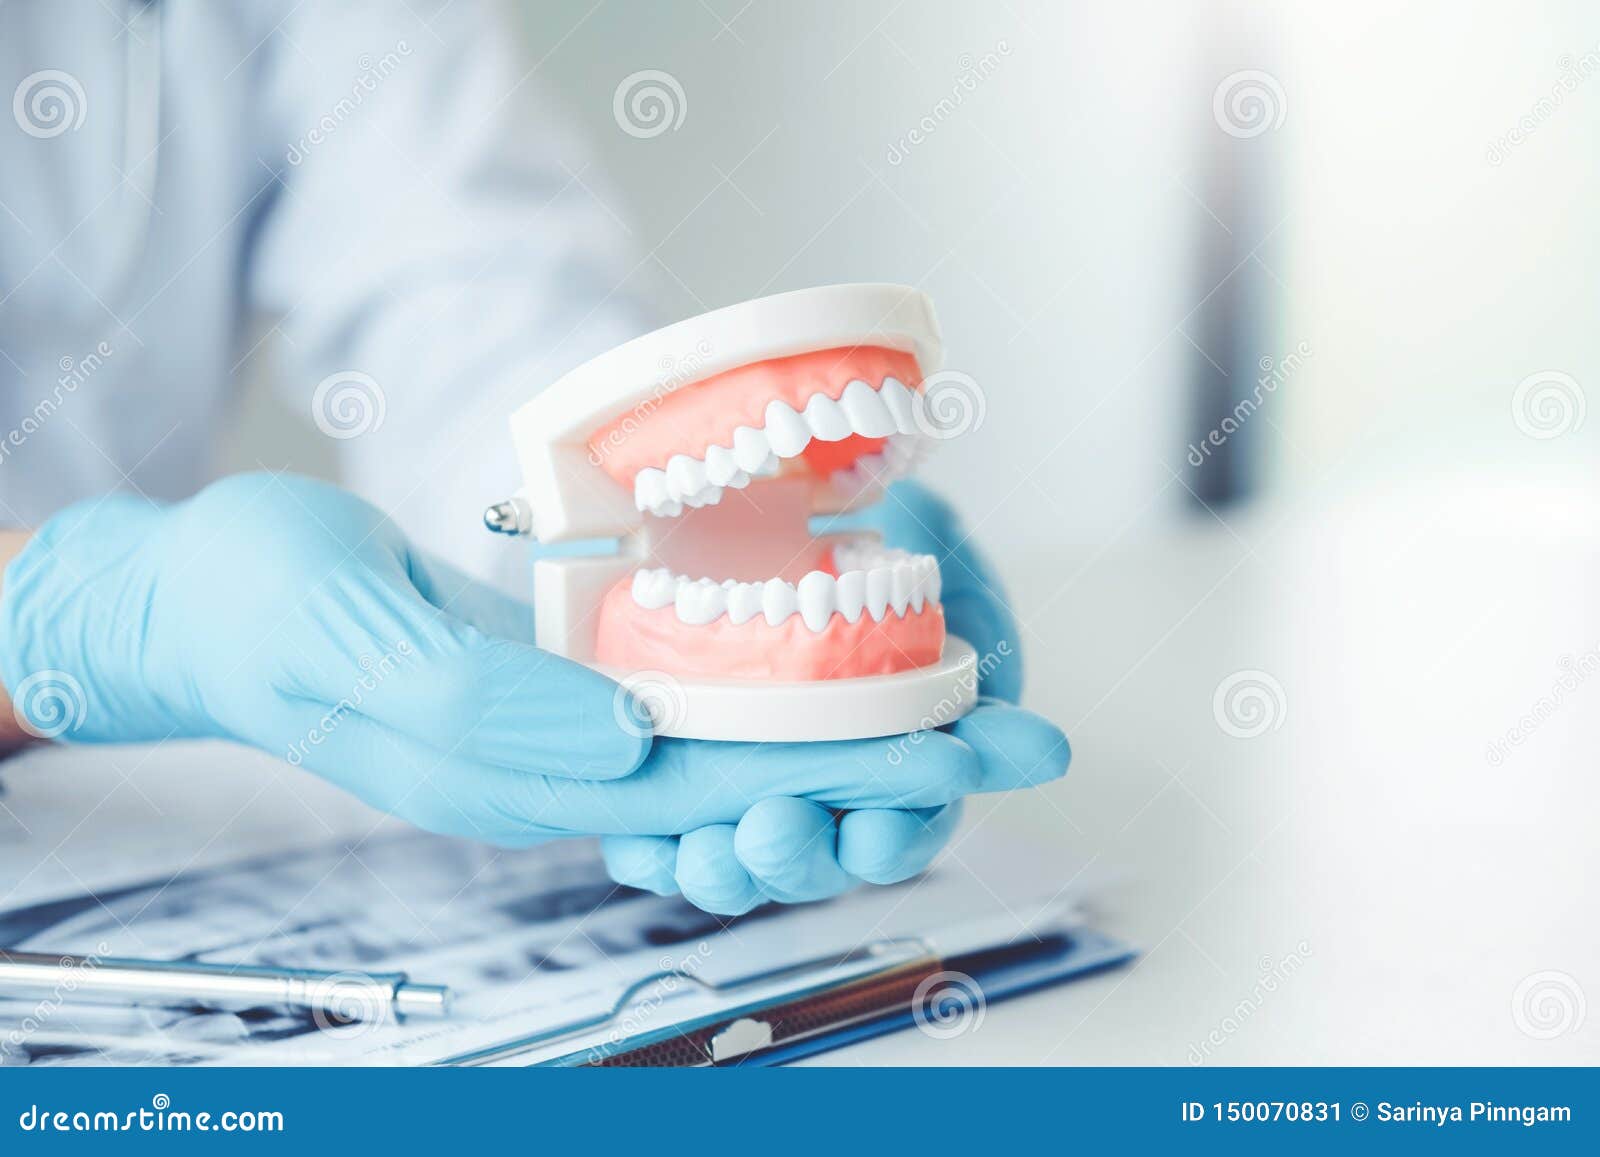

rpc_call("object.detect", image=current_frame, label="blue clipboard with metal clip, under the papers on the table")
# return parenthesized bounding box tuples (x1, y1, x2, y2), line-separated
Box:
(437, 912, 1134, 1067)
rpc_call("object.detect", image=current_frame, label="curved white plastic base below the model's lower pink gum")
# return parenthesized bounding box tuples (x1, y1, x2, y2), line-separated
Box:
(595, 635, 978, 743)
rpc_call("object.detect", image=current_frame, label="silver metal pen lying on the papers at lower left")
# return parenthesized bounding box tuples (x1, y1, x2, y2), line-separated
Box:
(0, 949, 450, 1021)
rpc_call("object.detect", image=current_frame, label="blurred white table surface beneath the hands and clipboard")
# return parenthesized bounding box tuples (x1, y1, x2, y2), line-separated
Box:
(0, 490, 1600, 1064)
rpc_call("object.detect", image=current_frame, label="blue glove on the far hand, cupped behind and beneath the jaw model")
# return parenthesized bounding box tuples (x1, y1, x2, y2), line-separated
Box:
(602, 482, 1070, 914)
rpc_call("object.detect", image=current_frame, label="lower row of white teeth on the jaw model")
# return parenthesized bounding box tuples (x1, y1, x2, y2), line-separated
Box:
(634, 547, 939, 631)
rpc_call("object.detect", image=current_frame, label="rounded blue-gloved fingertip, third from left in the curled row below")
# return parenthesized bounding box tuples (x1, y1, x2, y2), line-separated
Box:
(733, 795, 858, 904)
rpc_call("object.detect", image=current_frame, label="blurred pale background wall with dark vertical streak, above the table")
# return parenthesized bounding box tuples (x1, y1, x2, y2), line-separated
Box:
(229, 0, 1600, 550)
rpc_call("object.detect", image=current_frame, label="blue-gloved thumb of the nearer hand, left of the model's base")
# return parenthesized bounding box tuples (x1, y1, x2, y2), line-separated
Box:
(302, 560, 650, 779)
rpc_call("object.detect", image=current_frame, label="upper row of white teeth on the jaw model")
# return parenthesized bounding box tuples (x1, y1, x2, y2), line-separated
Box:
(634, 378, 917, 517)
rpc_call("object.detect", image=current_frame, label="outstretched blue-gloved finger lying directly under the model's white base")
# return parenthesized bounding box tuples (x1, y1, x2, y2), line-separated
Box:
(524, 731, 984, 835)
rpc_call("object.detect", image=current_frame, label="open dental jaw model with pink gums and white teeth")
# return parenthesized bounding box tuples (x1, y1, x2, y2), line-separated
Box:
(485, 285, 976, 741)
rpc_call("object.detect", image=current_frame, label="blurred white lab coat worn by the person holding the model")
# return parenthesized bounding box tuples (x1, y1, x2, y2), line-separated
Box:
(0, 0, 645, 586)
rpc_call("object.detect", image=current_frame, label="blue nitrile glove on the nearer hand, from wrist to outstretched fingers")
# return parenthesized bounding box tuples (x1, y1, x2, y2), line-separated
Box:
(0, 475, 1030, 870)
